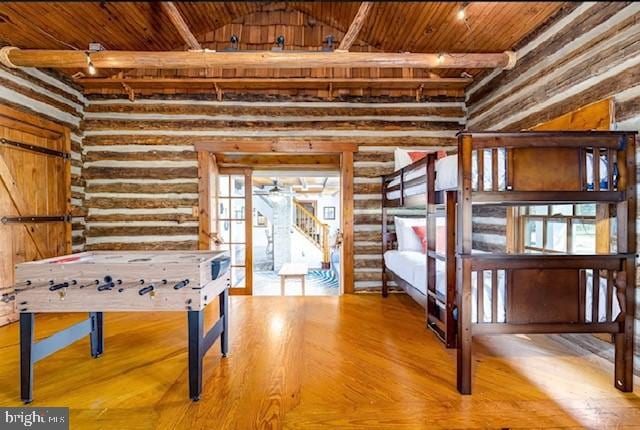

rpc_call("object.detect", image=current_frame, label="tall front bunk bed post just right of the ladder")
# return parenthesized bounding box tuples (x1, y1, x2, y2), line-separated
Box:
(456, 134, 473, 394)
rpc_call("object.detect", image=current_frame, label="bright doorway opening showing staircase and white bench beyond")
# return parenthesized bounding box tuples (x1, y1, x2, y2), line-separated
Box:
(251, 171, 341, 296)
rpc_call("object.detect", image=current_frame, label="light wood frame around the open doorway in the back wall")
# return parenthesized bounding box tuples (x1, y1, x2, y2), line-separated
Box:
(194, 138, 358, 294)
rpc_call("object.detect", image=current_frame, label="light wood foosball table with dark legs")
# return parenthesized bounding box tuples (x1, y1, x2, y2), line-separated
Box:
(2, 251, 230, 403)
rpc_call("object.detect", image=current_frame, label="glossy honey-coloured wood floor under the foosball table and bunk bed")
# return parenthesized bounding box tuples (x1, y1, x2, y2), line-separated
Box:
(0, 295, 640, 430)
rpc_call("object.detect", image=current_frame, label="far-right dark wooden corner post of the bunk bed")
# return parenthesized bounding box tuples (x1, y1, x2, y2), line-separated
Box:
(614, 135, 636, 392)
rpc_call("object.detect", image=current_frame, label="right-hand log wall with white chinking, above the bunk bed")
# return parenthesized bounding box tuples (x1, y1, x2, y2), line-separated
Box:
(466, 2, 640, 366)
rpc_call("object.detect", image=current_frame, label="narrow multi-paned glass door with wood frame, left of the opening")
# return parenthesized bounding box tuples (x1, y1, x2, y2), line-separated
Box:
(214, 169, 253, 295)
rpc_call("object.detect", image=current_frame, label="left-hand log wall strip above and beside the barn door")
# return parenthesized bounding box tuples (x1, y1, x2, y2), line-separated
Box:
(0, 66, 86, 252)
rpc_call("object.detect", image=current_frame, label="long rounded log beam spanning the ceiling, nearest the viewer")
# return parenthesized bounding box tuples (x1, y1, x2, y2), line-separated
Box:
(0, 46, 515, 69)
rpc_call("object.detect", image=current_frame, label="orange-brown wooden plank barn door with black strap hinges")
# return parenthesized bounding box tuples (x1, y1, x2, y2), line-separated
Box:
(0, 104, 71, 325)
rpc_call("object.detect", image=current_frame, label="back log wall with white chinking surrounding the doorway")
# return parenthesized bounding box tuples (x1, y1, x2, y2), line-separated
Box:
(83, 99, 465, 289)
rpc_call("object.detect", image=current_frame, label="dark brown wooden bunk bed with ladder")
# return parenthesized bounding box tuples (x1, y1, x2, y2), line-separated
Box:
(382, 132, 636, 394)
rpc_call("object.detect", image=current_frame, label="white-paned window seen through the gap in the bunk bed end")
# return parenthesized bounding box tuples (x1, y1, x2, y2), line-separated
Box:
(520, 204, 596, 254)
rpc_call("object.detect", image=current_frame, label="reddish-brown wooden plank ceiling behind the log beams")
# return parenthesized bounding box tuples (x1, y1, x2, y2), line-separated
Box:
(0, 2, 571, 95)
